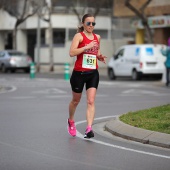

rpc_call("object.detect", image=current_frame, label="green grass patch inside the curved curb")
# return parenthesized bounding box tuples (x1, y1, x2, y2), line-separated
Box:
(120, 104, 170, 134)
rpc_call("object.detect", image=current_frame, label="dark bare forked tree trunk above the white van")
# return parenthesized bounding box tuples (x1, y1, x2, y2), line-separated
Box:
(124, 0, 153, 43)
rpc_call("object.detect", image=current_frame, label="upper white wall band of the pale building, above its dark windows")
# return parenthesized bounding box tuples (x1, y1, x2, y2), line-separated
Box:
(0, 10, 111, 30)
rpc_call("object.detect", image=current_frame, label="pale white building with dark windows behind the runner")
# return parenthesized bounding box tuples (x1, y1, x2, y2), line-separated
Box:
(0, 0, 113, 70)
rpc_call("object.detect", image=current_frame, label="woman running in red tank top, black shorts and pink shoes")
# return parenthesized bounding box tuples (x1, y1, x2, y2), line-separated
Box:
(68, 14, 106, 138)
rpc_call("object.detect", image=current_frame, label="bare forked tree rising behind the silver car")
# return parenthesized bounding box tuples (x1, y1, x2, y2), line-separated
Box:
(0, 0, 39, 49)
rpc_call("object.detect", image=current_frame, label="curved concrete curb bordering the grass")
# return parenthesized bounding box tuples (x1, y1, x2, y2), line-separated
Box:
(105, 117, 170, 149)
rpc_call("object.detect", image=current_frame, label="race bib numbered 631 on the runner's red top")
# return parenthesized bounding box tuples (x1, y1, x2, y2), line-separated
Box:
(82, 54, 96, 69)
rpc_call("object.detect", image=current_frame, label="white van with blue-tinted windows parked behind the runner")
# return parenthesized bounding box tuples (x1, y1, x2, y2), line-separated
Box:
(108, 44, 165, 80)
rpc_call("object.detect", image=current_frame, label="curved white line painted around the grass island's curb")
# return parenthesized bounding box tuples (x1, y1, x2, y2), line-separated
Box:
(76, 116, 170, 159)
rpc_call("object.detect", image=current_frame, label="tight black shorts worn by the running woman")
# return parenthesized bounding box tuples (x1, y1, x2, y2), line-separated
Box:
(70, 70, 99, 93)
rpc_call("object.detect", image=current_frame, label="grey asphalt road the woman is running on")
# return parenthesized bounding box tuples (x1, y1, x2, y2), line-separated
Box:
(0, 73, 170, 170)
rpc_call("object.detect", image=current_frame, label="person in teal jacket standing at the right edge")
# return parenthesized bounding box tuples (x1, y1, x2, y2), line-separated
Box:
(161, 37, 170, 86)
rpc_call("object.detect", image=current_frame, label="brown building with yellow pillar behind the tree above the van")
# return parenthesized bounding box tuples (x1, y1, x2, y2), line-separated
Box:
(113, 0, 170, 44)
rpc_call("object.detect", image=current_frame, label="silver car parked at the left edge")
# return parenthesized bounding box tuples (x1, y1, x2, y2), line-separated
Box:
(0, 50, 32, 73)
